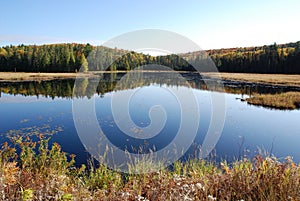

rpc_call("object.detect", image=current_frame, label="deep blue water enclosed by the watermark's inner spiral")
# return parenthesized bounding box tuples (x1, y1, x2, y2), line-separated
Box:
(96, 86, 180, 154)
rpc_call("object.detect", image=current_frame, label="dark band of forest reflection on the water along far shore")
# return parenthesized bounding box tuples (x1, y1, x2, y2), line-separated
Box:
(0, 72, 300, 99)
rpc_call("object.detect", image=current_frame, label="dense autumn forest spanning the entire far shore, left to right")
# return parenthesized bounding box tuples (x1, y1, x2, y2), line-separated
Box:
(0, 41, 300, 74)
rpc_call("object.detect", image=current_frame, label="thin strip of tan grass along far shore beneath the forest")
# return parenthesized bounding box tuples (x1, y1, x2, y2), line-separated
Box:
(0, 71, 300, 87)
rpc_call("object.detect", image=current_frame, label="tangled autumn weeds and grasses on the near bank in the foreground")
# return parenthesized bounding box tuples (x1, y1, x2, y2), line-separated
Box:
(0, 136, 300, 201)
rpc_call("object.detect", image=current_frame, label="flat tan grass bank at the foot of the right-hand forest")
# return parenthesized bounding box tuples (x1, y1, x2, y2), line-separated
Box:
(203, 73, 300, 87)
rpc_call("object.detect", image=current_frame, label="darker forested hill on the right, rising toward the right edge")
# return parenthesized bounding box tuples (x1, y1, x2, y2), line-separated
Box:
(183, 41, 300, 74)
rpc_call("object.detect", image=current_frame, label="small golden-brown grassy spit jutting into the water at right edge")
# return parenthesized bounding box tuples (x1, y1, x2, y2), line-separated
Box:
(246, 92, 300, 110)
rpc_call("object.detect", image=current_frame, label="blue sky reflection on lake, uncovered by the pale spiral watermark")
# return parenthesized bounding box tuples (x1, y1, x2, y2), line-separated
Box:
(0, 87, 300, 165)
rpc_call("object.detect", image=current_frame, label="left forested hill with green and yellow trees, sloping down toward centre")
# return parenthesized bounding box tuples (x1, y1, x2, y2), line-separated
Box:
(0, 44, 192, 72)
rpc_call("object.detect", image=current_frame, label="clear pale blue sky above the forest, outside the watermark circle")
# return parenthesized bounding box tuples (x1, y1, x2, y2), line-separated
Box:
(0, 0, 300, 49)
